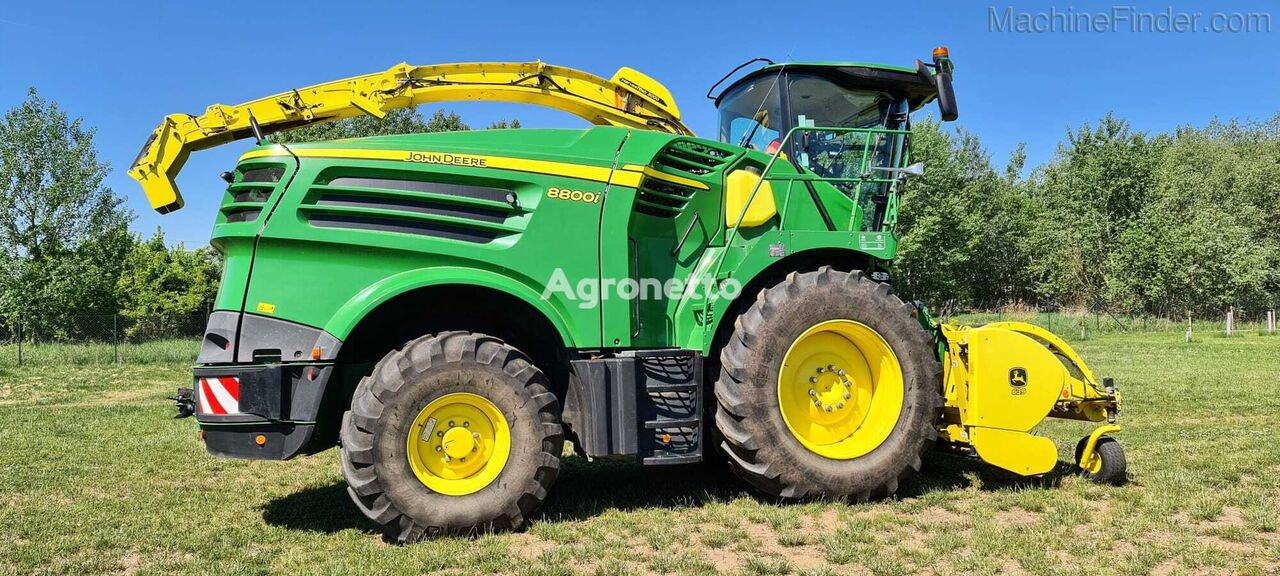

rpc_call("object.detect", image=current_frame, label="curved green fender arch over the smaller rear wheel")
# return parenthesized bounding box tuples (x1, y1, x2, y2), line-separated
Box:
(324, 266, 573, 348)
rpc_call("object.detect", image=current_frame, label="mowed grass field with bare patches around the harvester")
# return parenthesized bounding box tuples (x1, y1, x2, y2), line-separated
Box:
(0, 333, 1280, 576)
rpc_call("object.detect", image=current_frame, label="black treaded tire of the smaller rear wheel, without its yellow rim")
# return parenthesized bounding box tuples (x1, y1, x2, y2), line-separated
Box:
(342, 332, 564, 543)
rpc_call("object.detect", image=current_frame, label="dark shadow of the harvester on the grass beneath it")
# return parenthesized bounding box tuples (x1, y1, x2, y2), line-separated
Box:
(254, 452, 1074, 534)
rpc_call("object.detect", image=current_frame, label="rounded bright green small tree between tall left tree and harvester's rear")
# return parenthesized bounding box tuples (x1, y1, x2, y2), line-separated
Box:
(116, 229, 221, 339)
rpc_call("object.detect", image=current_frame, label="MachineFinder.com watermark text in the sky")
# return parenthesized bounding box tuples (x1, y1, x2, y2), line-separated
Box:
(987, 6, 1272, 35)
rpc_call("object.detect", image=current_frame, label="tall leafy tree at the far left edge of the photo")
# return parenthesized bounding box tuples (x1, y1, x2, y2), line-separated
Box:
(0, 88, 132, 337)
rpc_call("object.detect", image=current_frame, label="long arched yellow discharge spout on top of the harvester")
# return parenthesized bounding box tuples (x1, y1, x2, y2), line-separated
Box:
(129, 61, 692, 214)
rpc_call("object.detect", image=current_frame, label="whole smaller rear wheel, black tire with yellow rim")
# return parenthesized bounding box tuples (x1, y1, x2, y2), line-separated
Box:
(342, 332, 563, 543)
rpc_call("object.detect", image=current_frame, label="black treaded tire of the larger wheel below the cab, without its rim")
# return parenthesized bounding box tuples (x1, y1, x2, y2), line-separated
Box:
(716, 266, 942, 502)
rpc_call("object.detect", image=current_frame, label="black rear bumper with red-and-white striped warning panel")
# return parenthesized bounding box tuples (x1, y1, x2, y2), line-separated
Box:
(192, 362, 334, 460)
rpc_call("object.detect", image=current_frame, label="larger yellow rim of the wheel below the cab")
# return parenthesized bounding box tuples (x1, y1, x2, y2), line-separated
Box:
(778, 320, 905, 460)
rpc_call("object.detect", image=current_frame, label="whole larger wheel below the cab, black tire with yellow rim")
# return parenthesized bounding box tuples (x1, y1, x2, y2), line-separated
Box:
(716, 268, 942, 500)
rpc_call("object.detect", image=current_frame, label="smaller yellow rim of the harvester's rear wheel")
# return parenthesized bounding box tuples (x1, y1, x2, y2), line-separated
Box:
(407, 393, 511, 495)
